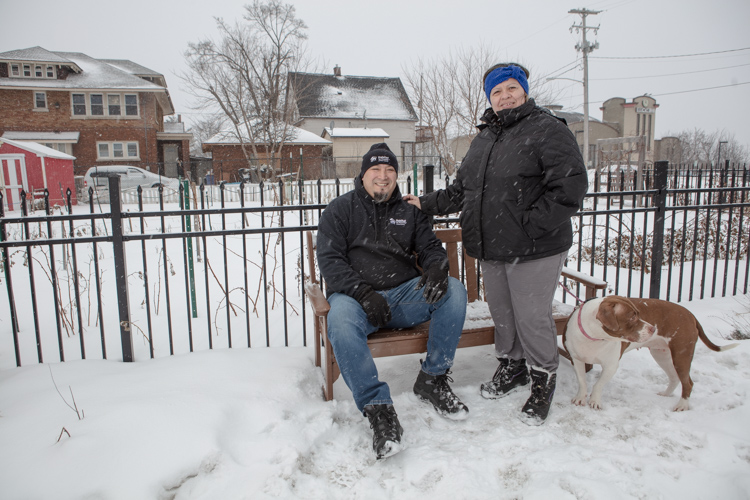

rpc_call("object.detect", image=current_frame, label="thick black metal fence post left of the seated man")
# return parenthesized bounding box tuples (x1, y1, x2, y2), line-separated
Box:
(108, 174, 133, 362)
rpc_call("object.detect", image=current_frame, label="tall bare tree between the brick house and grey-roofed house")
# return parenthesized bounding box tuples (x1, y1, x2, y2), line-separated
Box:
(180, 0, 322, 172)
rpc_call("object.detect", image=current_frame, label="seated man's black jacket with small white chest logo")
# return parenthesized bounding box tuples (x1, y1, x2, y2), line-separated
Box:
(317, 177, 448, 299)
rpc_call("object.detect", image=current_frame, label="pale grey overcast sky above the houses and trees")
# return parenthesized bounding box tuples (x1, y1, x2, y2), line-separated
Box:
(0, 0, 750, 146)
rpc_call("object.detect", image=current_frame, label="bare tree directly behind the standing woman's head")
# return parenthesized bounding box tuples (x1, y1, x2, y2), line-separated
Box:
(403, 43, 555, 175)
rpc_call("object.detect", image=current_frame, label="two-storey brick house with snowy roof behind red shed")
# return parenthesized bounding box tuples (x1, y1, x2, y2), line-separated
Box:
(0, 47, 191, 177)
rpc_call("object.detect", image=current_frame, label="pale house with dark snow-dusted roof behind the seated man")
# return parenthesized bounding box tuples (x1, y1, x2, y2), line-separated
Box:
(288, 66, 417, 161)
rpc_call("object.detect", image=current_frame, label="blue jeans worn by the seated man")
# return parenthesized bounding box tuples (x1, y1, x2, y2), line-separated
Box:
(328, 278, 466, 412)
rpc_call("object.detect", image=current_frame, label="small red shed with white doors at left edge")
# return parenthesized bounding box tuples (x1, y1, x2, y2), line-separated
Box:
(0, 138, 77, 210)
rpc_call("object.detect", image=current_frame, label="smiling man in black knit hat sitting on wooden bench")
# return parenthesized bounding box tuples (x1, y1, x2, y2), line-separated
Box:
(317, 143, 469, 458)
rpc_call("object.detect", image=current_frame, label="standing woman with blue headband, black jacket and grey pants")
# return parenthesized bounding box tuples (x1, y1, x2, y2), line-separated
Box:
(404, 60, 588, 425)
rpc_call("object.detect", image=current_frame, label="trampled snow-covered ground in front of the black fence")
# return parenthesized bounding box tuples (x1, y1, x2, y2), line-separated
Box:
(0, 296, 750, 500)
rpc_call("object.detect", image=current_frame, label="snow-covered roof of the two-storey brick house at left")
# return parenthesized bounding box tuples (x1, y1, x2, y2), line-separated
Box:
(0, 47, 174, 115)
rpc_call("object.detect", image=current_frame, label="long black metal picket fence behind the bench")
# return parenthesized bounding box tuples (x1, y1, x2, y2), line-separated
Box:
(0, 163, 750, 367)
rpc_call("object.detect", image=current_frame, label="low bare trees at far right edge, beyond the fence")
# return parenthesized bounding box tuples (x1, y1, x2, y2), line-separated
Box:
(666, 128, 750, 165)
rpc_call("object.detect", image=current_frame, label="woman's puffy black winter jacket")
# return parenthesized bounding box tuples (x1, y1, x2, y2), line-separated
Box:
(420, 99, 588, 262)
